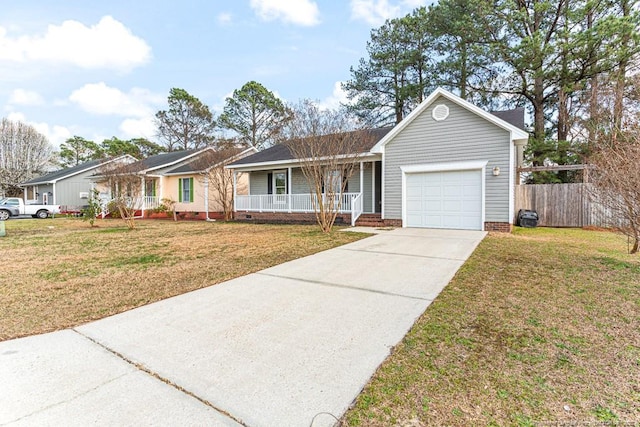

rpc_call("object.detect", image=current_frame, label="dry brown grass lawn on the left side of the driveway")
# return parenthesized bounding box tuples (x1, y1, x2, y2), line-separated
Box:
(0, 219, 363, 340)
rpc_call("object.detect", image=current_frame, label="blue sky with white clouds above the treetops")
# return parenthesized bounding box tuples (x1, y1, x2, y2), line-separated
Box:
(0, 0, 431, 147)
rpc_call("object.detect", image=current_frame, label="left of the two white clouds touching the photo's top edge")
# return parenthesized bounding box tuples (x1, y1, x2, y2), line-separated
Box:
(251, 0, 320, 27)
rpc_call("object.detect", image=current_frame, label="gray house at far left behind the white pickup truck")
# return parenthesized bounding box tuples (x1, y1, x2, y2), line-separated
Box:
(20, 155, 136, 212)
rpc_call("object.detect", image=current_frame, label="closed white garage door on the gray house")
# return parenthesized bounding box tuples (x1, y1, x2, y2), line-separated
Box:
(405, 170, 482, 230)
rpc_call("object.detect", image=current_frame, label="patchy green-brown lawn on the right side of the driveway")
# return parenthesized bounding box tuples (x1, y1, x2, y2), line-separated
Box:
(343, 228, 640, 427)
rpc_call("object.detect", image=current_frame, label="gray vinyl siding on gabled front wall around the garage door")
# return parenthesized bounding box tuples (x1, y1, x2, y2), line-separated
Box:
(383, 97, 511, 222)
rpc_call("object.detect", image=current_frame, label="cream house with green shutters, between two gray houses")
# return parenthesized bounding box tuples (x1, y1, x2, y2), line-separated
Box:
(93, 147, 256, 219)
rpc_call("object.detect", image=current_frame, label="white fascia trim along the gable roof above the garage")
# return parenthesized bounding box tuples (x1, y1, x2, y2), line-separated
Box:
(371, 87, 529, 153)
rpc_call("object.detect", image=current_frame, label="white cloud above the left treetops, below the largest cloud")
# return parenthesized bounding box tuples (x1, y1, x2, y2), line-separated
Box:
(69, 82, 164, 118)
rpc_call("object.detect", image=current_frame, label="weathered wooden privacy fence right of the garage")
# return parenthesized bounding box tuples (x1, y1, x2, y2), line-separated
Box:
(516, 183, 613, 227)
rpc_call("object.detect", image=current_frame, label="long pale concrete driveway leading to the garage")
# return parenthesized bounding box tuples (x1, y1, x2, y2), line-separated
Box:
(0, 228, 486, 426)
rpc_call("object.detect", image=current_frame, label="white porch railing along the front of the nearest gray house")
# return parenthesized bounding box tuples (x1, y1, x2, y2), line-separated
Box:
(236, 193, 363, 225)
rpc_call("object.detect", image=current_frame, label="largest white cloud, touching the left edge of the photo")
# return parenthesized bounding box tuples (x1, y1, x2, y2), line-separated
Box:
(0, 16, 151, 71)
